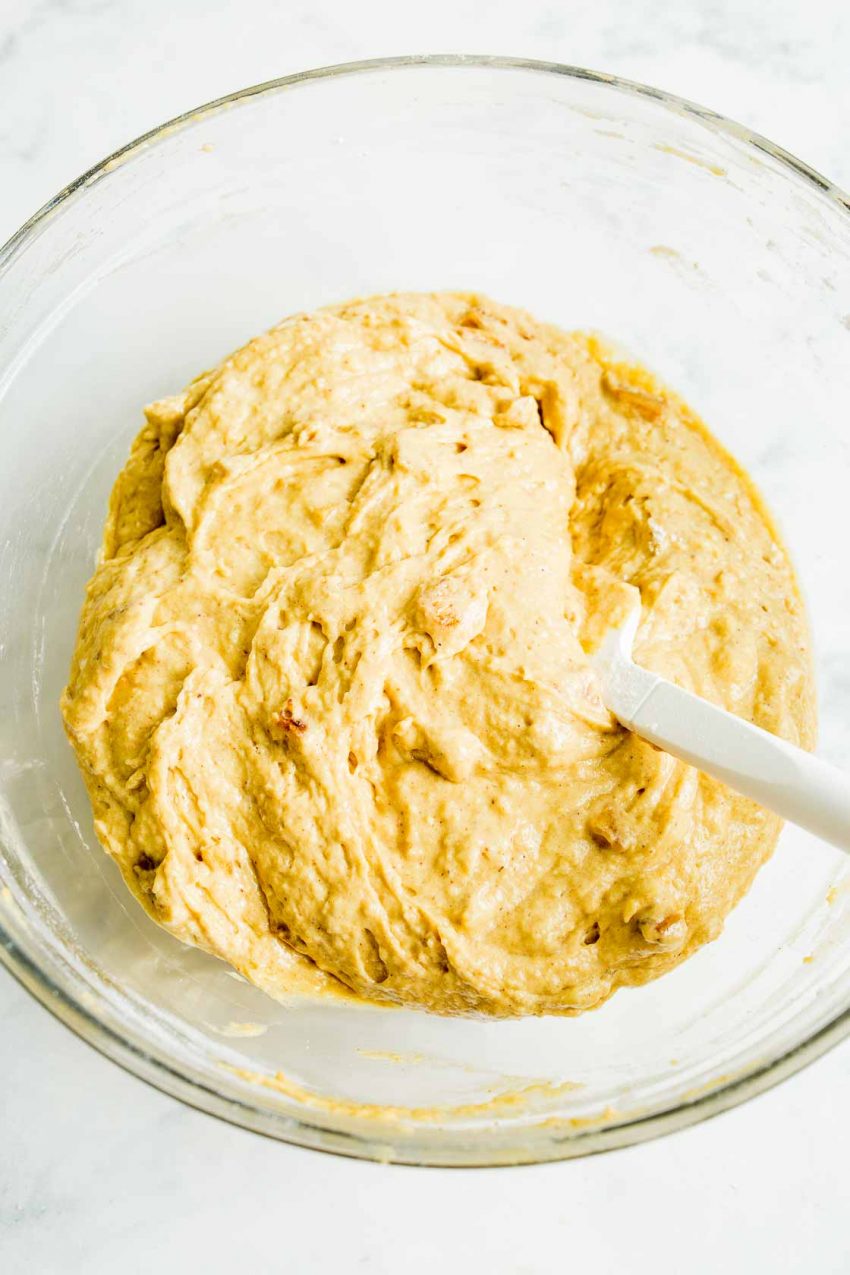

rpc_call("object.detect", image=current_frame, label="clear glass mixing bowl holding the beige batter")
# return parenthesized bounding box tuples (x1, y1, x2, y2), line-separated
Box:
(0, 57, 850, 1164)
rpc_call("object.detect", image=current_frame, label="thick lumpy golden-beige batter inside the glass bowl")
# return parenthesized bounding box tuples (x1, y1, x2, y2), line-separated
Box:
(62, 295, 813, 1015)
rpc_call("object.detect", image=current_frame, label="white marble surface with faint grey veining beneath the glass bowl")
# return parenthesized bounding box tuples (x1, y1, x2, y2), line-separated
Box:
(0, 0, 850, 1275)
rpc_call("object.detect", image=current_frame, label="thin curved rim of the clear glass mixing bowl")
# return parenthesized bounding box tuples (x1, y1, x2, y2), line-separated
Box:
(0, 54, 850, 1167)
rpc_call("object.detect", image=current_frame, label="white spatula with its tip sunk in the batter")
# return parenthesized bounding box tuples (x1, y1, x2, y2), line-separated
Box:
(594, 603, 850, 853)
